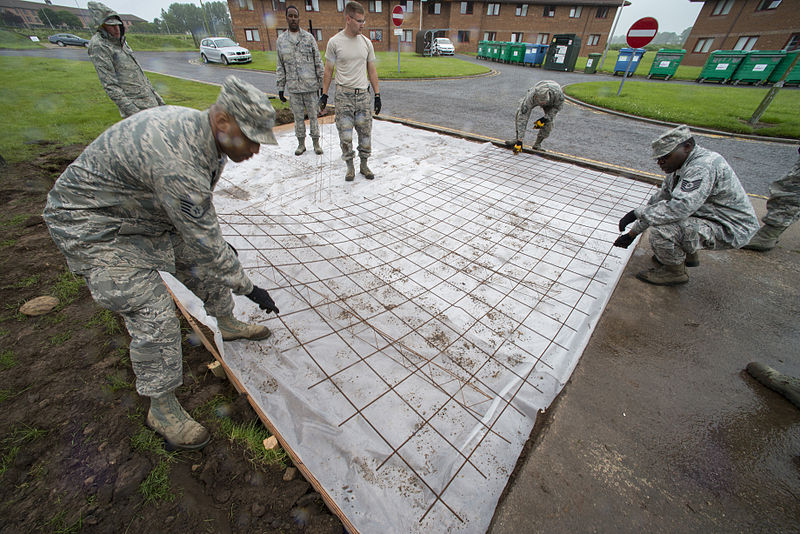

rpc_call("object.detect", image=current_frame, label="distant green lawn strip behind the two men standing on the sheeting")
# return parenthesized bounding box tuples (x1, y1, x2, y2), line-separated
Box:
(231, 51, 492, 79)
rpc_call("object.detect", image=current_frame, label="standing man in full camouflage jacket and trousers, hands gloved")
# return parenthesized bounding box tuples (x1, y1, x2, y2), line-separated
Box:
(275, 6, 324, 156)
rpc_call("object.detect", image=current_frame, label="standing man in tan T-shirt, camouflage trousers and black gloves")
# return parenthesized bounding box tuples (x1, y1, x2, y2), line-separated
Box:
(319, 2, 381, 182)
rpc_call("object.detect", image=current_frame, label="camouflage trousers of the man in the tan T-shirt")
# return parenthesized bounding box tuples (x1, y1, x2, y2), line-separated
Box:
(334, 85, 372, 161)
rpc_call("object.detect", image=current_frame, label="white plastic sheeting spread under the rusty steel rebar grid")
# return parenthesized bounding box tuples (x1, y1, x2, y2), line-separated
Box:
(164, 122, 653, 533)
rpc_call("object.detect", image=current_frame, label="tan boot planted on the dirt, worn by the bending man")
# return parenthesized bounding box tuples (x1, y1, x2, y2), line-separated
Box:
(146, 391, 211, 450)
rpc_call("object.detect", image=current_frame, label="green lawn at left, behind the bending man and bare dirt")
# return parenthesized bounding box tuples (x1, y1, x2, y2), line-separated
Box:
(0, 56, 228, 162)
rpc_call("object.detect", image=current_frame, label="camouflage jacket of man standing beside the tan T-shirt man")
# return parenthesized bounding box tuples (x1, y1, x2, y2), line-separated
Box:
(275, 29, 325, 93)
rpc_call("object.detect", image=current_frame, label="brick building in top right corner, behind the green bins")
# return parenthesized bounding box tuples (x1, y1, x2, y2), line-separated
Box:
(682, 0, 800, 66)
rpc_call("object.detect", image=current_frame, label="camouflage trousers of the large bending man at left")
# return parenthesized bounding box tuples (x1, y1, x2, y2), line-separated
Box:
(79, 238, 233, 397)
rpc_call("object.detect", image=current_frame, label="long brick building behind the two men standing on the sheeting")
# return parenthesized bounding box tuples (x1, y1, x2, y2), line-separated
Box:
(228, 0, 630, 55)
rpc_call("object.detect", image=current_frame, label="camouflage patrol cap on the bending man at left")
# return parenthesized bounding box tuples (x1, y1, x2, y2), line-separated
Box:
(217, 76, 278, 145)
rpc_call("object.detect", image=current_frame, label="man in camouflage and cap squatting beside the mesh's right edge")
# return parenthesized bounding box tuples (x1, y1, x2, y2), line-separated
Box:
(614, 125, 758, 285)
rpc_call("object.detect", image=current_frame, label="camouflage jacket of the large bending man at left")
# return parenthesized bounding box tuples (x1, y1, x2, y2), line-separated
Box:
(44, 106, 253, 294)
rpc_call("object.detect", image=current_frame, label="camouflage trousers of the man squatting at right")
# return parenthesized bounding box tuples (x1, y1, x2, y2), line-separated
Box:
(650, 217, 731, 265)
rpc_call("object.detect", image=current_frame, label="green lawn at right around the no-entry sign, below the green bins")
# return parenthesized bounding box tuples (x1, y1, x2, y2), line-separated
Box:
(564, 78, 800, 138)
